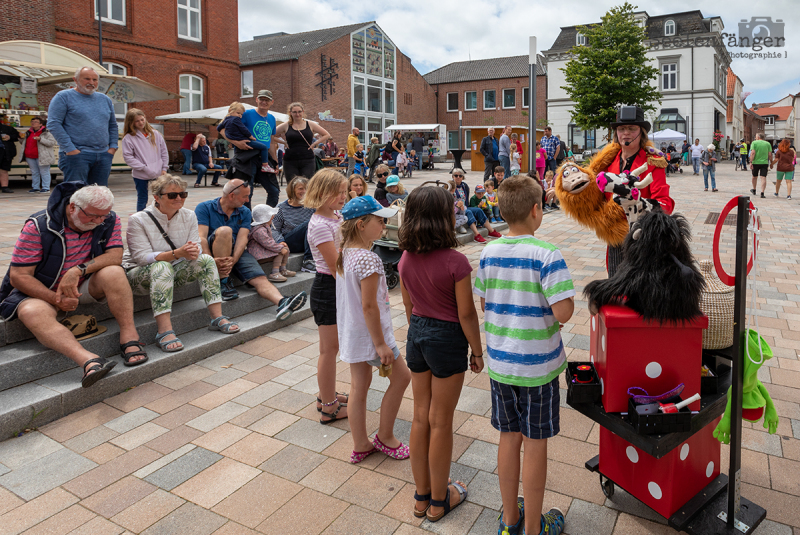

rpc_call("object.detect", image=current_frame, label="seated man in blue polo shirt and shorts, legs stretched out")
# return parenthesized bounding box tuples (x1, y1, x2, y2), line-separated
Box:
(194, 178, 306, 321)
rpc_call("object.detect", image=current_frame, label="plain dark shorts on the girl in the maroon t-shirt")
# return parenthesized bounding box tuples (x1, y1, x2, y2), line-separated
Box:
(406, 315, 469, 379)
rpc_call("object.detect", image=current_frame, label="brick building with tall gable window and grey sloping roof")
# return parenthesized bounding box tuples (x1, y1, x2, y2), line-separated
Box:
(237, 22, 436, 145)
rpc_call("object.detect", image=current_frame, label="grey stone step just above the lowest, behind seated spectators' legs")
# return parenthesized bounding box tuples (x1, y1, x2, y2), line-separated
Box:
(0, 273, 314, 391)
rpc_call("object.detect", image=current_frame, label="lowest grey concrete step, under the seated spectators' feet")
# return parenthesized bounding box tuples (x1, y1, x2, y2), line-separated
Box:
(0, 302, 311, 440)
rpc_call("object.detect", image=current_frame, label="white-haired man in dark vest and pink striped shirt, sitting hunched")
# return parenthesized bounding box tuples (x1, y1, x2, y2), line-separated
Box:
(0, 182, 147, 388)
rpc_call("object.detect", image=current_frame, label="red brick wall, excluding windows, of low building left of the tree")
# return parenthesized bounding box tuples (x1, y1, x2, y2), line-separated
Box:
(433, 76, 547, 153)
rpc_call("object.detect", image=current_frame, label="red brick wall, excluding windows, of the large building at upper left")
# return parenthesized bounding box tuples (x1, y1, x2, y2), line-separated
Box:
(51, 0, 240, 149)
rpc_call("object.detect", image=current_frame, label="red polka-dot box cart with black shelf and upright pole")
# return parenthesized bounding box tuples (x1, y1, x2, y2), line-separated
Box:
(567, 197, 766, 535)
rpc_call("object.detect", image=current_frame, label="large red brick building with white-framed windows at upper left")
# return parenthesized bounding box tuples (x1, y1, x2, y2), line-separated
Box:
(0, 0, 239, 148)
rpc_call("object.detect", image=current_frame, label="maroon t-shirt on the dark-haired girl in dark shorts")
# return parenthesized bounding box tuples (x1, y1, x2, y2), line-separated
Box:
(398, 249, 472, 323)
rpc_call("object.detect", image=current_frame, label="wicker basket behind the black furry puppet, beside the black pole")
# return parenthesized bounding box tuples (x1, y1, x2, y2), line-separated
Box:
(700, 260, 734, 349)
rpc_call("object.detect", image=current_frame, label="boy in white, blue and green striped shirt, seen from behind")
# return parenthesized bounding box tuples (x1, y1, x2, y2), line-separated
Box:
(474, 176, 575, 535)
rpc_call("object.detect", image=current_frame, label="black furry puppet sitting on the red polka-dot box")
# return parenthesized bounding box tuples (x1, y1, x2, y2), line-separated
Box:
(583, 210, 705, 324)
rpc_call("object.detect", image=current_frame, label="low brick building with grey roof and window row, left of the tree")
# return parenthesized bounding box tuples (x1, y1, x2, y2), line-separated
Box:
(424, 56, 547, 154)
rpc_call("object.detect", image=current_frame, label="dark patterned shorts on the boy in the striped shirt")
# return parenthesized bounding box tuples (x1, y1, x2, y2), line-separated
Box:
(490, 377, 561, 440)
